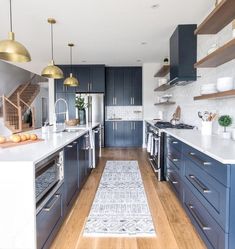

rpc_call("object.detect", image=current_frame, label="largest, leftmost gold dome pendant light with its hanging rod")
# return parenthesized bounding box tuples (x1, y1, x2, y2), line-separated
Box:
(0, 0, 31, 62)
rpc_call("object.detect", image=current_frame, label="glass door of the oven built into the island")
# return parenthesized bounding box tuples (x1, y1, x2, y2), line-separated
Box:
(35, 155, 61, 204)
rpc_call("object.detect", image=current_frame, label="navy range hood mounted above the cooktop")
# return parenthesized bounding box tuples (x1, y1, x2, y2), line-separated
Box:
(168, 24, 197, 85)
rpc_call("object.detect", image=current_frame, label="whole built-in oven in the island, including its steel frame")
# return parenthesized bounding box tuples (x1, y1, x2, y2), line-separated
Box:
(35, 151, 64, 207)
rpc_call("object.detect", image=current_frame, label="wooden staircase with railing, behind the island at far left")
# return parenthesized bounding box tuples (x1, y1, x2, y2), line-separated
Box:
(2, 77, 40, 133)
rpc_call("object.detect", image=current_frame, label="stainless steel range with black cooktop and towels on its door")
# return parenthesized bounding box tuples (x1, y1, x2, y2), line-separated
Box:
(146, 121, 194, 181)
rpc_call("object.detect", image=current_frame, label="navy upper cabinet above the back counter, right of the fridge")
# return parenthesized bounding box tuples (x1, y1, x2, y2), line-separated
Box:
(105, 67, 142, 106)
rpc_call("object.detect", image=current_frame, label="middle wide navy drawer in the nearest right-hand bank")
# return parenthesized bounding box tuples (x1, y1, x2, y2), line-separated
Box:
(184, 160, 229, 231)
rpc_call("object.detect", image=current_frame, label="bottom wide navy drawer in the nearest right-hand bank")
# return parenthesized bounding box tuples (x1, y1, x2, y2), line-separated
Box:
(184, 188, 228, 249)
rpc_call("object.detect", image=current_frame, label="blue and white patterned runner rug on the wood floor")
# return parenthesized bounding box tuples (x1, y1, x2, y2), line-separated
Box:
(84, 161, 156, 237)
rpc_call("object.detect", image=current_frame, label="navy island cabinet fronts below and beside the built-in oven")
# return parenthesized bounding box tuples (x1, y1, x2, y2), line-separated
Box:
(36, 134, 90, 249)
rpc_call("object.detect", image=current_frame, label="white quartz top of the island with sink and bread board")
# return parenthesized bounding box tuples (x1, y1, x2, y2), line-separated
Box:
(0, 123, 99, 164)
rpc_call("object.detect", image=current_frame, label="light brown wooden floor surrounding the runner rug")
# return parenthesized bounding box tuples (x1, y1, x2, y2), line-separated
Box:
(51, 149, 206, 249)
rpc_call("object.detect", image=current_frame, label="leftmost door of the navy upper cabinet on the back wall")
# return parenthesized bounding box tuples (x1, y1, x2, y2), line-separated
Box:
(105, 68, 114, 106)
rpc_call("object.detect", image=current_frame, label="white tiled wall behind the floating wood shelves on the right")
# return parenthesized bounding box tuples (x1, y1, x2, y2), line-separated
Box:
(155, 25, 235, 133)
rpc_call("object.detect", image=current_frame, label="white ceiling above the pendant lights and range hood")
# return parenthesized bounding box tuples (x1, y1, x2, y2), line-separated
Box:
(0, 0, 215, 73)
